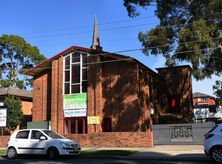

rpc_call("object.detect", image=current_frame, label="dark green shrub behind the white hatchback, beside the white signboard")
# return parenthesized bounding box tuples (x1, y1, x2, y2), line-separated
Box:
(4, 96, 23, 130)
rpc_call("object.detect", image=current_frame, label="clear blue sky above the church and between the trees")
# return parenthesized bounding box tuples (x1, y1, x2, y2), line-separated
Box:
(0, 0, 220, 96)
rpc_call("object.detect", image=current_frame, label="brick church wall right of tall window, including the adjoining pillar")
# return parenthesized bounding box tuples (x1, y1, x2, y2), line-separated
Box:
(87, 57, 158, 133)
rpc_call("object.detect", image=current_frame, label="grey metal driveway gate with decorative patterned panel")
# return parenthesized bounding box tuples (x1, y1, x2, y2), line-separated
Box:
(153, 122, 215, 145)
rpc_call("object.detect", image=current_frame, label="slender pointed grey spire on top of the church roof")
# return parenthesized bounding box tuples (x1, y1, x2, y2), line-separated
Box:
(91, 16, 102, 51)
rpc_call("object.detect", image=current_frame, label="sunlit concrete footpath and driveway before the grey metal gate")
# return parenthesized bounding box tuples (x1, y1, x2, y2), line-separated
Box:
(82, 145, 209, 161)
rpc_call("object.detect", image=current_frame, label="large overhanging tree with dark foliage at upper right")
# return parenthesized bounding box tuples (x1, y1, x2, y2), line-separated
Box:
(123, 0, 222, 79)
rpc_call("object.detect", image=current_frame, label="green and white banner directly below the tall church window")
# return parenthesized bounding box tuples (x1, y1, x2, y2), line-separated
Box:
(64, 93, 87, 109)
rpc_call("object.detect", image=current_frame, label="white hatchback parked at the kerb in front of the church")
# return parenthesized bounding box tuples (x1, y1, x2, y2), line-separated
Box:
(7, 129, 81, 159)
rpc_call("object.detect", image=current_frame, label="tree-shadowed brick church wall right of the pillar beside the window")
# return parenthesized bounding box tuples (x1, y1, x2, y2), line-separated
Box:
(101, 59, 159, 132)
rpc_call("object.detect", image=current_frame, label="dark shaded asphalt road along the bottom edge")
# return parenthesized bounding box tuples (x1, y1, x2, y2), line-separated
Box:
(0, 157, 217, 164)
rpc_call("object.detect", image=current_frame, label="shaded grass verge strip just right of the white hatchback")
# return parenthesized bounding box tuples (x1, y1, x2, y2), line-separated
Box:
(80, 150, 136, 156)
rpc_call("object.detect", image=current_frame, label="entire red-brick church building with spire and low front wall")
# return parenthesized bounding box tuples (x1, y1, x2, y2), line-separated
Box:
(26, 17, 192, 147)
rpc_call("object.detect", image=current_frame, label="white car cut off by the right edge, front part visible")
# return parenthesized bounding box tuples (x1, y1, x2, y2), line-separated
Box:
(204, 124, 222, 163)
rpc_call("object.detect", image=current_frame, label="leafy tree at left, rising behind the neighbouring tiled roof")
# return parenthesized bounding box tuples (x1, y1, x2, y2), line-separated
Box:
(0, 35, 46, 89)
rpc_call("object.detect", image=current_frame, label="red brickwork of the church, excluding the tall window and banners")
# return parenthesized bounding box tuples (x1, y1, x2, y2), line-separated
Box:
(29, 47, 192, 147)
